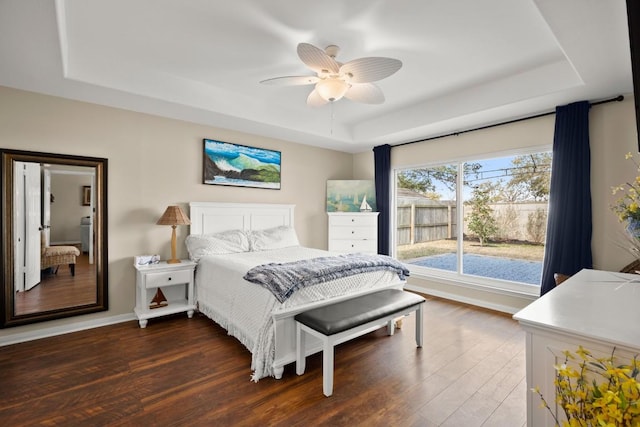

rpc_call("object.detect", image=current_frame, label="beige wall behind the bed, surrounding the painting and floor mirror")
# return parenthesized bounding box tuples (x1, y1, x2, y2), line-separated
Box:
(0, 87, 353, 342)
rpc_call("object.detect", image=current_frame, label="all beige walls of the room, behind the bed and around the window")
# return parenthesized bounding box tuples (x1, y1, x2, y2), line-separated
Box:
(0, 87, 637, 343)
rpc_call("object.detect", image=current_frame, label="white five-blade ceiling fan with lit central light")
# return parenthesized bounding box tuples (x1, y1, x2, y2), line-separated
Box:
(260, 43, 402, 107)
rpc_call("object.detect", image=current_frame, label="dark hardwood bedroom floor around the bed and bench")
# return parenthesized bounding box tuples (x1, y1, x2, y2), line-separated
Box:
(0, 298, 526, 427)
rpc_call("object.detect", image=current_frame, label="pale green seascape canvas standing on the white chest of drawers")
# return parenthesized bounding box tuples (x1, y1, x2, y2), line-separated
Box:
(327, 179, 376, 212)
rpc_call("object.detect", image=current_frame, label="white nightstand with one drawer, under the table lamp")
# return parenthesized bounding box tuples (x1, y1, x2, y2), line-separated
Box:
(134, 260, 196, 328)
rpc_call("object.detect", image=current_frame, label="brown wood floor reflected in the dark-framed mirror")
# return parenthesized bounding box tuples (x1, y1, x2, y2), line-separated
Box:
(15, 249, 96, 315)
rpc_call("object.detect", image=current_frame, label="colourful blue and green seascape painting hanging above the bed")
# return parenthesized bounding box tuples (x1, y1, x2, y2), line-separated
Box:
(202, 139, 281, 190)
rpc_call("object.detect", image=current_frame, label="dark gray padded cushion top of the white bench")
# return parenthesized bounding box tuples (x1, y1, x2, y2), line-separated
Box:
(295, 289, 425, 335)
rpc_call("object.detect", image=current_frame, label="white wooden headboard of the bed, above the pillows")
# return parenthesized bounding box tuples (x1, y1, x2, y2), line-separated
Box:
(189, 202, 295, 234)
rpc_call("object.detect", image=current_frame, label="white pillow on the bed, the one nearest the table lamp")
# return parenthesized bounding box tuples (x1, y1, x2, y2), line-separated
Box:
(186, 230, 249, 262)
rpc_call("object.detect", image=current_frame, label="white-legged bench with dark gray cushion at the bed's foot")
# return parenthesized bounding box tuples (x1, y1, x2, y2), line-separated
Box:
(295, 289, 425, 397)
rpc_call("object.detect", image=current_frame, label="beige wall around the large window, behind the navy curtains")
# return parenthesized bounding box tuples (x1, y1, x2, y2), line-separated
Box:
(354, 95, 638, 311)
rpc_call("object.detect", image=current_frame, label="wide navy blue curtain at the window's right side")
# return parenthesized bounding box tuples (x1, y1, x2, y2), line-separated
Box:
(540, 101, 593, 295)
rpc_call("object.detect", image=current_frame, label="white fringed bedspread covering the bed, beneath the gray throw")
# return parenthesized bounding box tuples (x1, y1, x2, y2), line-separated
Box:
(196, 246, 399, 381)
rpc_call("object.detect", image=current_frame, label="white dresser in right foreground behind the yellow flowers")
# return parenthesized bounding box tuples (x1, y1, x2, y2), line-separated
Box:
(513, 269, 640, 427)
